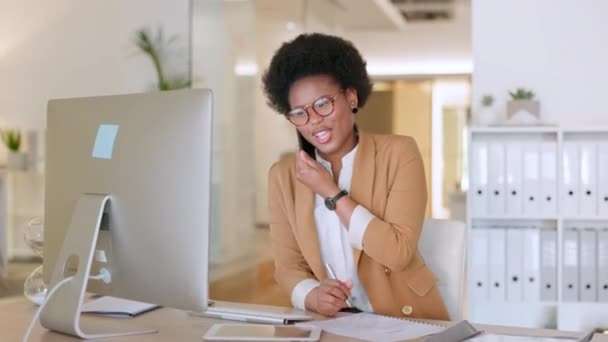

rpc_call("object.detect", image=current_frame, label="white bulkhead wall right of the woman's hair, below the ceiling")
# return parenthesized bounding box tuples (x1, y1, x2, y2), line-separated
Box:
(343, 1, 472, 76)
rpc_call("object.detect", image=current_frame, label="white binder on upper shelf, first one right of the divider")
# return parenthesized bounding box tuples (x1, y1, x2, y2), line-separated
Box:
(560, 141, 580, 217)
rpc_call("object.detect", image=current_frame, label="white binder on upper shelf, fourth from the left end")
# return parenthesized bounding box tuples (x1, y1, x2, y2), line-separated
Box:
(523, 143, 541, 216)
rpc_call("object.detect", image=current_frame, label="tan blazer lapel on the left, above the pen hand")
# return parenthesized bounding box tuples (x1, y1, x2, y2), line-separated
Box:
(294, 176, 327, 280)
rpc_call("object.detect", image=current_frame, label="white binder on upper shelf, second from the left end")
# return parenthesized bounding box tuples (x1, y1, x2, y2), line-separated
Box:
(488, 142, 505, 216)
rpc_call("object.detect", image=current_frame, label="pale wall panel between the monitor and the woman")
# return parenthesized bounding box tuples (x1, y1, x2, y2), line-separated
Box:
(192, 0, 256, 264)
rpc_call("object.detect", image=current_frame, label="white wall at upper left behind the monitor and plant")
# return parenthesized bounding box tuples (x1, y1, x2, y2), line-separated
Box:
(0, 0, 189, 130)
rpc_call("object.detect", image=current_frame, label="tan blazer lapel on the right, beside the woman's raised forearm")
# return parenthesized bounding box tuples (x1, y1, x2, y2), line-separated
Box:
(350, 131, 376, 267)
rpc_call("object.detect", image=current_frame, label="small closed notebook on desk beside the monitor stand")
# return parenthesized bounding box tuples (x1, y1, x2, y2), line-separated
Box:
(80, 296, 159, 317)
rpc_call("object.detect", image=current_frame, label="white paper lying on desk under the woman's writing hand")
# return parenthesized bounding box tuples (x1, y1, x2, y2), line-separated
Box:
(305, 313, 446, 341)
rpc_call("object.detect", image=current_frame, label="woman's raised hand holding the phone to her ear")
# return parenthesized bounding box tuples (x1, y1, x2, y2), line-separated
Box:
(296, 150, 340, 198)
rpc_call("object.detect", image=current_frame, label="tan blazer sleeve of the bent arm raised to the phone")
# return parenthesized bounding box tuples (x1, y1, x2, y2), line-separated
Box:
(363, 138, 427, 271)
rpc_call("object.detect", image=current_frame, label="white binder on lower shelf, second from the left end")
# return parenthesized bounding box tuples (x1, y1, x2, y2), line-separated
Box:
(488, 228, 506, 302)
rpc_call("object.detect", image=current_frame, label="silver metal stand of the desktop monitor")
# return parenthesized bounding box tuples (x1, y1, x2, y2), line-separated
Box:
(40, 194, 156, 339)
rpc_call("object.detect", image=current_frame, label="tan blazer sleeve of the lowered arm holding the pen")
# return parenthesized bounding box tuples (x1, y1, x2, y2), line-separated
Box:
(268, 164, 316, 295)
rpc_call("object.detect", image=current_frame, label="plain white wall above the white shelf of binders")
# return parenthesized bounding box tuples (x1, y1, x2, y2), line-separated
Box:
(473, 0, 608, 125)
